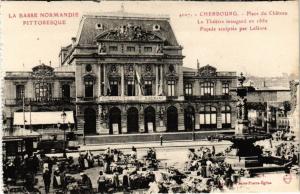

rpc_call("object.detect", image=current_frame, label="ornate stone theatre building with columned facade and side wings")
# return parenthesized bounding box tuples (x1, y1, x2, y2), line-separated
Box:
(5, 12, 236, 142)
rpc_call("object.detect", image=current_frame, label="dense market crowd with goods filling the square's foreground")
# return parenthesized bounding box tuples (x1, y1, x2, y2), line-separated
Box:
(3, 126, 299, 194)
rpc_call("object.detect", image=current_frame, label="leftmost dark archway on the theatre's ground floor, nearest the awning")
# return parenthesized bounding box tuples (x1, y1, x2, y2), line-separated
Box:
(84, 108, 96, 134)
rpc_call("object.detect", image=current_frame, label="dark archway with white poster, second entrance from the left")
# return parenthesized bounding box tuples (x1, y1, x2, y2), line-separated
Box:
(109, 107, 121, 134)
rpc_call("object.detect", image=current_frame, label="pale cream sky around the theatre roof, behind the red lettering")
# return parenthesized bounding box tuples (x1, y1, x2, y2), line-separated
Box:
(1, 1, 299, 76)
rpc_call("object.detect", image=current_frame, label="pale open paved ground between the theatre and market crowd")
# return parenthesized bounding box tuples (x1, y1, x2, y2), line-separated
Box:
(37, 141, 230, 193)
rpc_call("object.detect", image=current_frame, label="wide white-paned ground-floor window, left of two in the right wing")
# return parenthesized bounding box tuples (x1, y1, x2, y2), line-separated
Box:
(200, 106, 217, 128)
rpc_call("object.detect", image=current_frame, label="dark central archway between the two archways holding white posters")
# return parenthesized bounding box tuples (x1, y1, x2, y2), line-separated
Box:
(127, 107, 139, 133)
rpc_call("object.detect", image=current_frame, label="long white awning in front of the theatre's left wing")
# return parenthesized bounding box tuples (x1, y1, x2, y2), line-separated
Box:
(14, 111, 74, 125)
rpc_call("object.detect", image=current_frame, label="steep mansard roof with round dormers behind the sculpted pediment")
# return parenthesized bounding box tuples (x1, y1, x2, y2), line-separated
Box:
(76, 12, 179, 46)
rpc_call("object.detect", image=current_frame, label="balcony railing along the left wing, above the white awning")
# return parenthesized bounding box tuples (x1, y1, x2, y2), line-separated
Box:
(5, 98, 75, 105)
